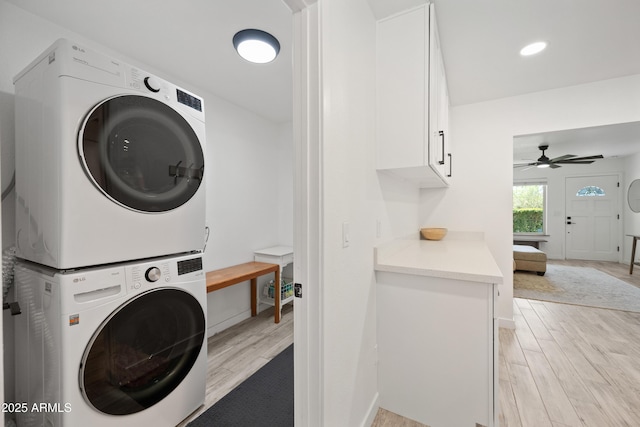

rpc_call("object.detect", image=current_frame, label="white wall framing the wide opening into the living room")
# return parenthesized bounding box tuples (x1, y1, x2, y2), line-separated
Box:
(420, 75, 640, 327)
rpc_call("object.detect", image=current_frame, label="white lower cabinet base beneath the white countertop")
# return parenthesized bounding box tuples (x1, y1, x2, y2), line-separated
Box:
(376, 271, 498, 427)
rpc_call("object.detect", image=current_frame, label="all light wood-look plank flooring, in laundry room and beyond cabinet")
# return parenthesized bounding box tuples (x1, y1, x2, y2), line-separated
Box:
(181, 260, 640, 427)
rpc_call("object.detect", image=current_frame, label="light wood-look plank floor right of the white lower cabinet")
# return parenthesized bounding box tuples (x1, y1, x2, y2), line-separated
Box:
(499, 260, 640, 427)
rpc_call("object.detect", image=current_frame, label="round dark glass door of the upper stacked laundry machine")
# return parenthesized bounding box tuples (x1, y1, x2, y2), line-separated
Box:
(78, 95, 204, 212)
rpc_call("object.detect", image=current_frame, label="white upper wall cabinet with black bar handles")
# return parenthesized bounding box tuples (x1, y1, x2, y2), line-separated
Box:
(376, 4, 451, 187)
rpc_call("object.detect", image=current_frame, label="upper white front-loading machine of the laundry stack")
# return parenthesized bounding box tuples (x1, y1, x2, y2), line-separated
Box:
(14, 39, 205, 269)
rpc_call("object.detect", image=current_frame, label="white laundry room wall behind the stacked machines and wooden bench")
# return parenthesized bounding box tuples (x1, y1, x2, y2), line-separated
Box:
(0, 0, 293, 401)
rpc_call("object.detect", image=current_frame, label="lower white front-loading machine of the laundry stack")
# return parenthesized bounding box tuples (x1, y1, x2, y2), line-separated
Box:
(15, 255, 207, 427)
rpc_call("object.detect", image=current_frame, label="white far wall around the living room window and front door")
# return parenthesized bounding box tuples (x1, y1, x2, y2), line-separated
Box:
(513, 152, 624, 259)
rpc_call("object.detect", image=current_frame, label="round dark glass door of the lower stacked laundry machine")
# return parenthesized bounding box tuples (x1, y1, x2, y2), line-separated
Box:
(79, 288, 205, 415)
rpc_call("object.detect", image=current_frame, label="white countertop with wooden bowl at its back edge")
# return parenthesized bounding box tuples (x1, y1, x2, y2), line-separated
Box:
(374, 232, 503, 284)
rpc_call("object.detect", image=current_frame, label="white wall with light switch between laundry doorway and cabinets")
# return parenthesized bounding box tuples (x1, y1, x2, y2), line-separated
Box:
(318, 0, 418, 426)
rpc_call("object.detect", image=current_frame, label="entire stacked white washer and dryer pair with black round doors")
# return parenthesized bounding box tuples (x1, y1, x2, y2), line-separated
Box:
(14, 39, 206, 427)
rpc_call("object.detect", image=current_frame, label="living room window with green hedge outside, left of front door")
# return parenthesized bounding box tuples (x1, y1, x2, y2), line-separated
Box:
(513, 182, 547, 234)
